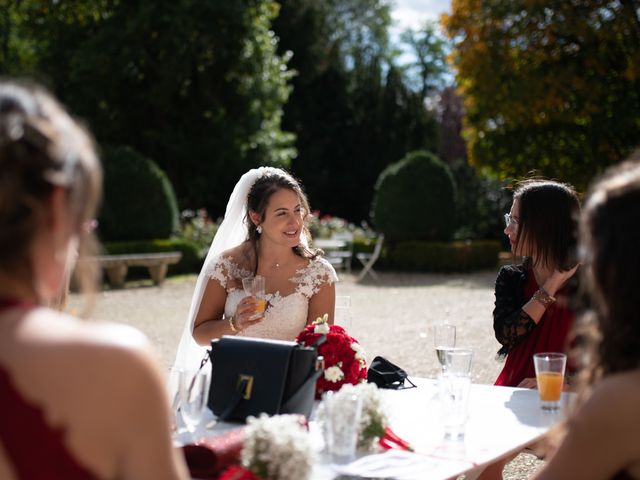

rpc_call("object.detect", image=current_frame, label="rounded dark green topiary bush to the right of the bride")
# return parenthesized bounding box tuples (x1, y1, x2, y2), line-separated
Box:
(371, 151, 456, 244)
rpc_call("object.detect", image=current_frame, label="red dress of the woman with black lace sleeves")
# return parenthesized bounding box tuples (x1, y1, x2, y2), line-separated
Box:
(495, 272, 575, 387)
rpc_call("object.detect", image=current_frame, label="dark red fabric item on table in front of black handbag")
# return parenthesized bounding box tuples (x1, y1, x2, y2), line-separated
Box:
(182, 427, 245, 479)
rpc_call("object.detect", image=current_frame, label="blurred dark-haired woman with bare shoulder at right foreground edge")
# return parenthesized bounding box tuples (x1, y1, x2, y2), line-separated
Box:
(536, 159, 640, 480)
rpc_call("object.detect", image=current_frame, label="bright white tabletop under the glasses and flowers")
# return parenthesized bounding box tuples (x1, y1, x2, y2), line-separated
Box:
(177, 377, 569, 480)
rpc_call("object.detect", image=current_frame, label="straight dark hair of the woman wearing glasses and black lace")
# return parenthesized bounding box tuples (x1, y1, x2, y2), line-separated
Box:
(513, 179, 580, 270)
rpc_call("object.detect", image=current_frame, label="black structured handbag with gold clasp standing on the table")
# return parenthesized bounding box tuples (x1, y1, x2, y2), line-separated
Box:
(207, 336, 325, 421)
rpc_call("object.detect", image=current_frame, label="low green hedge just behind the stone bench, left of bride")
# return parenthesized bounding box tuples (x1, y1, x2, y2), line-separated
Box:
(103, 238, 204, 274)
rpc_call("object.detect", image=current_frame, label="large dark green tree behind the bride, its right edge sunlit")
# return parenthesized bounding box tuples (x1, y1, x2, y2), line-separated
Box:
(11, 0, 295, 214)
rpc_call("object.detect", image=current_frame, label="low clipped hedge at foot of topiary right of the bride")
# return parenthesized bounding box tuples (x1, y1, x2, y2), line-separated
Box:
(382, 240, 500, 272)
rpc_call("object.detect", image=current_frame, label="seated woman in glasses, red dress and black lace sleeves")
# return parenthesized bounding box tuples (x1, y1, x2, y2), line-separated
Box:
(493, 180, 580, 387)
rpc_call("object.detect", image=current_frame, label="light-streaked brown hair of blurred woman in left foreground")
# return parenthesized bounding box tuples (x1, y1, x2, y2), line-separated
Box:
(0, 79, 102, 302)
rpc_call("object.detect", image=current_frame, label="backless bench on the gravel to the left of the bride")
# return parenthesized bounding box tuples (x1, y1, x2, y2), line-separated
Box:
(91, 252, 182, 288)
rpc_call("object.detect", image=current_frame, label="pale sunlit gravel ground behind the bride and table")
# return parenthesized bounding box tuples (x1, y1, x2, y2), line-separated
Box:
(70, 271, 541, 480)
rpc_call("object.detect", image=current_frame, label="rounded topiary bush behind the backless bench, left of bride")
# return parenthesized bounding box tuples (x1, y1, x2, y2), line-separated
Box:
(99, 146, 179, 241)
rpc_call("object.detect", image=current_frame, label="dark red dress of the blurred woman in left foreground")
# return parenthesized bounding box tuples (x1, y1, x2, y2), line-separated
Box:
(0, 299, 96, 480)
